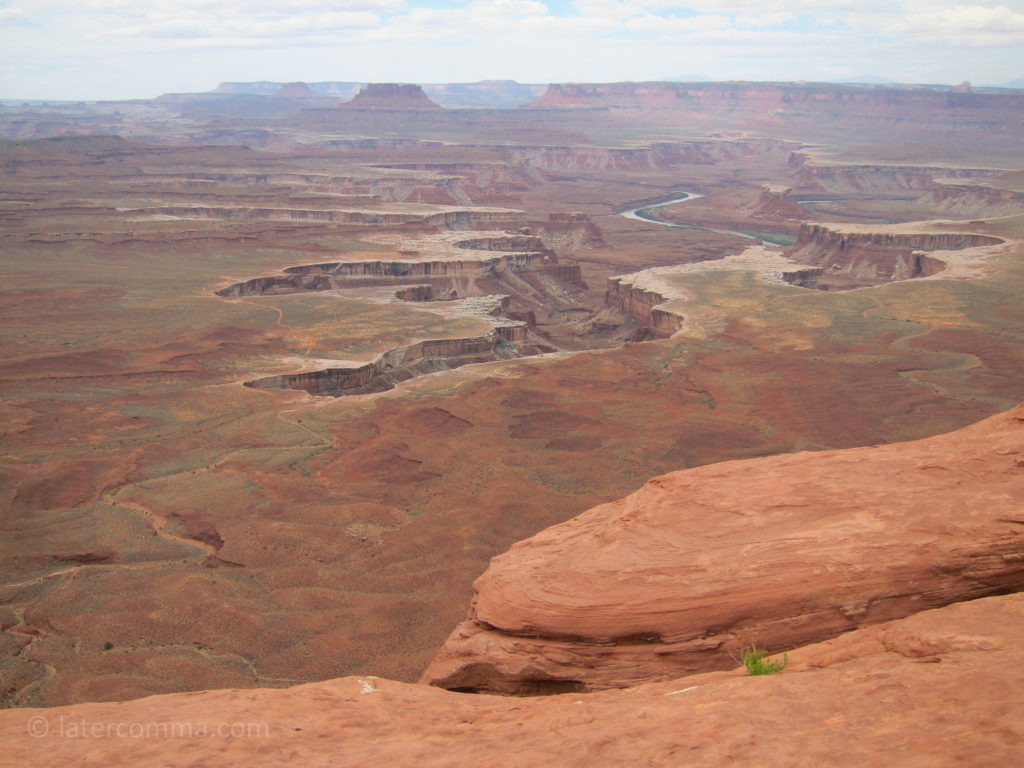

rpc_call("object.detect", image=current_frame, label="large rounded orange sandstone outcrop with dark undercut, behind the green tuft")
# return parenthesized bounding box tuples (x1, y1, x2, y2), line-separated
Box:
(423, 406, 1024, 693)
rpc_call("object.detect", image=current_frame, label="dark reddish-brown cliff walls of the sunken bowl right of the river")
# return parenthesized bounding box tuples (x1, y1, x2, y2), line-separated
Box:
(786, 223, 1004, 290)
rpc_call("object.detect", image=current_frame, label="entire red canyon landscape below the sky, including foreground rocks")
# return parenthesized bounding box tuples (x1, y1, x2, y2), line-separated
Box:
(0, 81, 1024, 765)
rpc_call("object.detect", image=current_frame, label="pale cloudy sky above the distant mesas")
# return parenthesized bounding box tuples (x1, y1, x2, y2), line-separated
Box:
(0, 0, 1024, 100)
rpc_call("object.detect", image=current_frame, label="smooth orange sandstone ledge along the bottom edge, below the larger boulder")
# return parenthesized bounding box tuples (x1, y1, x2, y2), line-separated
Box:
(0, 595, 1024, 768)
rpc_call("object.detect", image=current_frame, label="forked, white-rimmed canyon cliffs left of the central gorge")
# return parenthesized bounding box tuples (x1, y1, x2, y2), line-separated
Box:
(216, 231, 610, 396)
